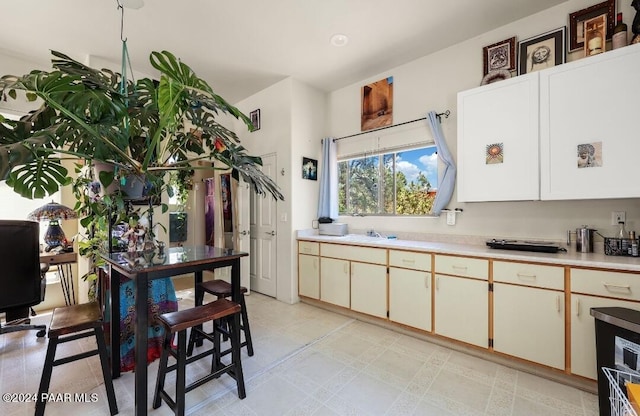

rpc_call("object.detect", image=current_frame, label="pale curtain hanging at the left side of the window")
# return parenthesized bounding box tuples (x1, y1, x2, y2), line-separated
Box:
(318, 137, 338, 220)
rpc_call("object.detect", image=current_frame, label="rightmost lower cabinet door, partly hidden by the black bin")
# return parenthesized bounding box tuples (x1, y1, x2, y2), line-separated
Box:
(571, 294, 640, 380)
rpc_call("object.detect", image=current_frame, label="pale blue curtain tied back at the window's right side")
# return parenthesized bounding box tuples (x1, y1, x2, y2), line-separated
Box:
(427, 111, 456, 215)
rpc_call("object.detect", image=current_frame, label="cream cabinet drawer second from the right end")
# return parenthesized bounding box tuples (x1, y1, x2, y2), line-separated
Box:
(493, 261, 564, 290)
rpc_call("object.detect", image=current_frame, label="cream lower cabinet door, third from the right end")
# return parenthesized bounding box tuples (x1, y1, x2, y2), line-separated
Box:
(434, 275, 489, 348)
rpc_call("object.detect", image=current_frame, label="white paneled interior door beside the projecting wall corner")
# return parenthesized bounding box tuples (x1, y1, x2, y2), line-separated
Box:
(249, 154, 277, 297)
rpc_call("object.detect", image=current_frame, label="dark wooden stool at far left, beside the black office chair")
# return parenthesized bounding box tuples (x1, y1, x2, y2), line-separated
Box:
(35, 302, 118, 416)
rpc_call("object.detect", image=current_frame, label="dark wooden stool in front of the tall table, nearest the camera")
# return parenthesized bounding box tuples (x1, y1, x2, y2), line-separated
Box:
(153, 299, 246, 416)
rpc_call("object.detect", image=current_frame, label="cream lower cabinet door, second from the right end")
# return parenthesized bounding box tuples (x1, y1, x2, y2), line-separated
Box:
(493, 283, 564, 370)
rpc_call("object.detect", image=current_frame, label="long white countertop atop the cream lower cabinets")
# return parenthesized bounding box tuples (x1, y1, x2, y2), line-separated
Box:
(297, 231, 640, 272)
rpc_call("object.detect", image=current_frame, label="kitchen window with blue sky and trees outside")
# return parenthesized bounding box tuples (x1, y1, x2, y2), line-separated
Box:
(338, 145, 438, 215)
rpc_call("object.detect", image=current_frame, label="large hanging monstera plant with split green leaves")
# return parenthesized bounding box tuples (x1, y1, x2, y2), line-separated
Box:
(0, 51, 283, 199)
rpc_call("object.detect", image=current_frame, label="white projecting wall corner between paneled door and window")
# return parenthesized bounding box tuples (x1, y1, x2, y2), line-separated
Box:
(235, 78, 326, 303)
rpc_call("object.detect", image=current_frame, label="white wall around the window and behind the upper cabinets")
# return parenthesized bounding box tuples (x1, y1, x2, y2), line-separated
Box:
(328, 0, 640, 240)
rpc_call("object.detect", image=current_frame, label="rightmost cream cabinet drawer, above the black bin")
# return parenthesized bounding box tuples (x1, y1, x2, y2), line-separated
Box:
(571, 269, 640, 300)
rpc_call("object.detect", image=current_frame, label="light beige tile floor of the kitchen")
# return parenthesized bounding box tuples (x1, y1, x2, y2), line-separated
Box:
(0, 290, 598, 416)
